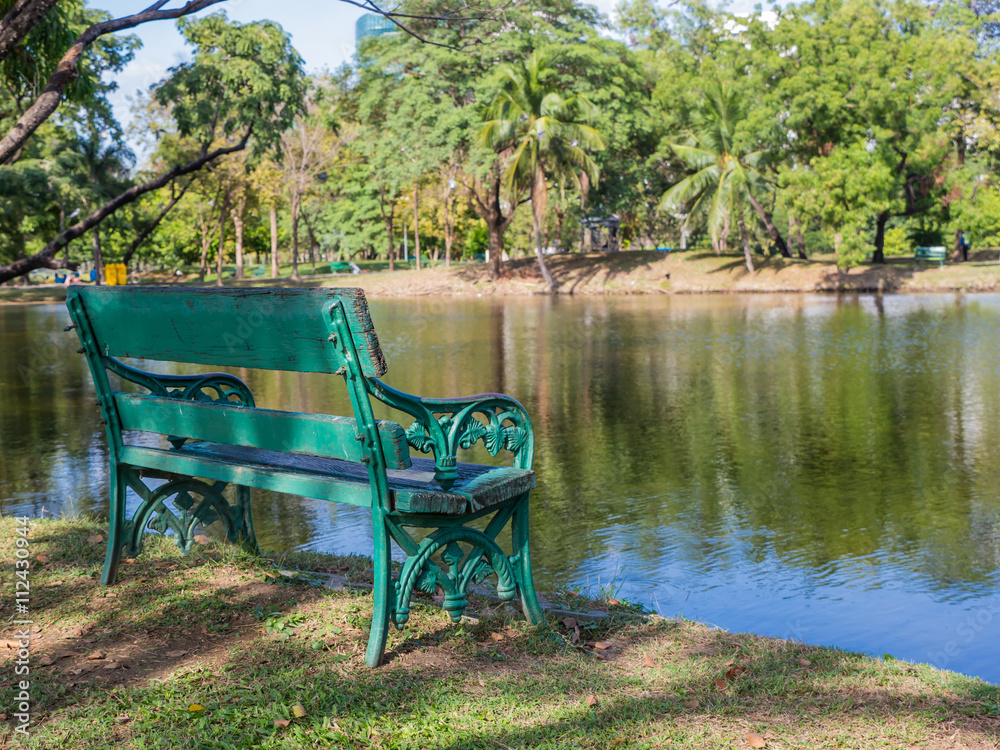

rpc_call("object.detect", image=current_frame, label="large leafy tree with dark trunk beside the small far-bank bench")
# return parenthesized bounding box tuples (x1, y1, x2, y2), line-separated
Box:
(741, 0, 979, 263)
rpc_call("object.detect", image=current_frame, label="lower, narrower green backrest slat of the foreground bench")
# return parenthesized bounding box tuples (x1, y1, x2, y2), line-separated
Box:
(115, 393, 410, 469)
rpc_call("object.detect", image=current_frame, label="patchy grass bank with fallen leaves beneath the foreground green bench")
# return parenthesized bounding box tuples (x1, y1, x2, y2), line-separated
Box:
(0, 518, 1000, 750)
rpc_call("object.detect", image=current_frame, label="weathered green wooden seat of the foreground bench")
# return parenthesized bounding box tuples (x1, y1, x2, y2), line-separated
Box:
(122, 440, 535, 516)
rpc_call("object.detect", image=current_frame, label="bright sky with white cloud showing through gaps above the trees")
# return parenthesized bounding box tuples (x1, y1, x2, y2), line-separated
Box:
(99, 0, 754, 143)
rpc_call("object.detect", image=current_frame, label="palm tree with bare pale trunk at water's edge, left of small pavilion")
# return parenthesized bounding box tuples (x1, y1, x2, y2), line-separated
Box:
(479, 50, 604, 291)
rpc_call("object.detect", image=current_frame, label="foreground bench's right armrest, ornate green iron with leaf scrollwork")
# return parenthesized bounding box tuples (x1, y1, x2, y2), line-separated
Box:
(366, 378, 535, 490)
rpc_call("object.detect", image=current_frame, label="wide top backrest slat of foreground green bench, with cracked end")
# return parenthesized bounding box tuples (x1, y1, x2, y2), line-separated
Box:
(67, 287, 386, 377)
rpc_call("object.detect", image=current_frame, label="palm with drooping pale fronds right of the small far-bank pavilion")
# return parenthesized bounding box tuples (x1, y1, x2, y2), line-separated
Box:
(660, 84, 791, 273)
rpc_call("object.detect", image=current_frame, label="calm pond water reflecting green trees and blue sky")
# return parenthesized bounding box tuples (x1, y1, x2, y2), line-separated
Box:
(0, 295, 1000, 682)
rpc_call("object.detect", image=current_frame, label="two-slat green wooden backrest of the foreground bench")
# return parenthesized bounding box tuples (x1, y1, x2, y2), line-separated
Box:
(67, 287, 410, 468)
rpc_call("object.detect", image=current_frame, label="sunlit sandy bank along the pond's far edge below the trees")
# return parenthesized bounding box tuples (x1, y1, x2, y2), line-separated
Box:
(0, 250, 1000, 305)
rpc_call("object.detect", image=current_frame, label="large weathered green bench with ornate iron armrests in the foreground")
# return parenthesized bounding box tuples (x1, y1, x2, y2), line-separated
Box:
(66, 287, 545, 666)
